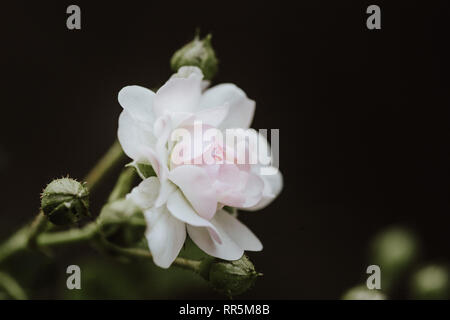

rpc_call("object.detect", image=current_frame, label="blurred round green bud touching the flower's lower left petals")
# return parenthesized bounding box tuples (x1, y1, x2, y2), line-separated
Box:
(98, 199, 147, 247)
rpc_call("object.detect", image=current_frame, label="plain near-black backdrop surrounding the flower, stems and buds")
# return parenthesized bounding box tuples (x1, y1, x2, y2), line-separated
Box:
(0, 1, 450, 299)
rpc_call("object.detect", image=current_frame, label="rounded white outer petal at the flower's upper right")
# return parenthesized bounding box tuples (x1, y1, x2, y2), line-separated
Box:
(199, 83, 255, 129)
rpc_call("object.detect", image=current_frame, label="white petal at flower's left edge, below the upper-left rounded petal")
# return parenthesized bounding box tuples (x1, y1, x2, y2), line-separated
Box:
(117, 110, 156, 161)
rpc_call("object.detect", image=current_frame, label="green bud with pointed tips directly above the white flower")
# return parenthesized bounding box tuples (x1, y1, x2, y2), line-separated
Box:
(170, 34, 219, 80)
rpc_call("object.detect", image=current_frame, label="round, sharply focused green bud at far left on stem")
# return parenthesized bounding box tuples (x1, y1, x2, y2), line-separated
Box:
(41, 178, 89, 225)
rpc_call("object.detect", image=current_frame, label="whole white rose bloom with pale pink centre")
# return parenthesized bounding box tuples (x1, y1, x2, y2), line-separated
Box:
(118, 67, 282, 268)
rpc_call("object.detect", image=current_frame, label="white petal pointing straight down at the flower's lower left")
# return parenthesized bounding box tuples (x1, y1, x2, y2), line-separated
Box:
(145, 207, 186, 268)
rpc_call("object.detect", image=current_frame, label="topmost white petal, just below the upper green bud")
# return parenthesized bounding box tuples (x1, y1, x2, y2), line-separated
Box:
(153, 67, 203, 116)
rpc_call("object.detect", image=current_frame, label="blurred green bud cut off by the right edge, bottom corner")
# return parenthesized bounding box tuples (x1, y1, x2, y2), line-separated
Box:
(411, 265, 450, 299)
